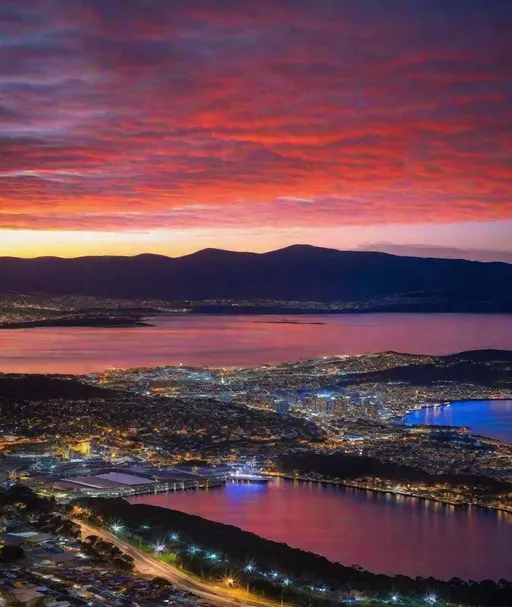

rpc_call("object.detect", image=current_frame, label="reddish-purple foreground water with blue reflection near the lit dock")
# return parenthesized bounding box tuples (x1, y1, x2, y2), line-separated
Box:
(128, 480, 512, 581)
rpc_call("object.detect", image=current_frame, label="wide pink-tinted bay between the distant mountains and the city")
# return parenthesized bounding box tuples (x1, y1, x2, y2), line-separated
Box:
(0, 314, 512, 373)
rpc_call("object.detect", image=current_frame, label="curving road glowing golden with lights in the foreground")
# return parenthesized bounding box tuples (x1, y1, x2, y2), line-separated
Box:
(78, 519, 291, 607)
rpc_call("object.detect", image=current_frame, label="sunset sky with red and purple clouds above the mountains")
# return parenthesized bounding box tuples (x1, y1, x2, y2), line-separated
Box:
(0, 0, 512, 261)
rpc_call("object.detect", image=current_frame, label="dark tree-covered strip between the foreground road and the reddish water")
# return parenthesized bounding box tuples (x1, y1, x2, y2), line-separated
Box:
(79, 498, 512, 607)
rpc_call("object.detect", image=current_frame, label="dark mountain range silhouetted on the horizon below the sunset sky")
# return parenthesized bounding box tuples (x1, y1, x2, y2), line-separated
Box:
(0, 245, 512, 312)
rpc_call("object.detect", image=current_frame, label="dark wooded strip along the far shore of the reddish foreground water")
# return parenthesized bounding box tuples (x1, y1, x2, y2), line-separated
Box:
(275, 452, 512, 495)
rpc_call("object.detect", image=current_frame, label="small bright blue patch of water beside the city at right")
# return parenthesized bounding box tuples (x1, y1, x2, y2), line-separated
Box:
(404, 400, 512, 444)
